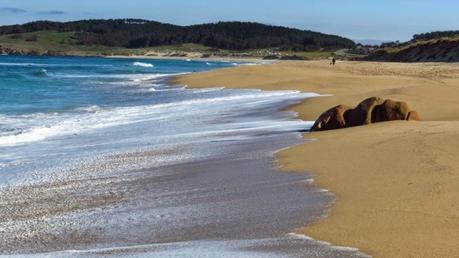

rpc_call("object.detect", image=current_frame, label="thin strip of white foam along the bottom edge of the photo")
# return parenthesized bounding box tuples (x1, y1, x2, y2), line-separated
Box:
(11, 237, 371, 258)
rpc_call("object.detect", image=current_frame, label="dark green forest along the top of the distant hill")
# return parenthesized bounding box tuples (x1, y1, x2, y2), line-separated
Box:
(0, 19, 355, 51)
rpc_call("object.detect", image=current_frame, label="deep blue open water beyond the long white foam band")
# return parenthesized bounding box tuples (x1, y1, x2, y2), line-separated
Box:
(0, 56, 230, 115)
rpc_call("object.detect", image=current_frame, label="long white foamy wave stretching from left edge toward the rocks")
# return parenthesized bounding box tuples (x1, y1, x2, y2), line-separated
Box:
(0, 88, 319, 146)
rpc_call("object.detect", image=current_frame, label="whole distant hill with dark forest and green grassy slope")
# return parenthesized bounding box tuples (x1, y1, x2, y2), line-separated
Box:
(0, 19, 355, 57)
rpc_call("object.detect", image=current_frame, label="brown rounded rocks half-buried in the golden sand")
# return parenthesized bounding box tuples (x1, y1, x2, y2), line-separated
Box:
(311, 97, 420, 131)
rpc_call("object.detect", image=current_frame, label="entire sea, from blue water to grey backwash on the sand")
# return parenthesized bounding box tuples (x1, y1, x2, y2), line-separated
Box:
(0, 56, 361, 257)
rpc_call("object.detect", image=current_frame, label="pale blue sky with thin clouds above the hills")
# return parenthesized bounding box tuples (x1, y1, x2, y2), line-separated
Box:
(0, 0, 459, 41)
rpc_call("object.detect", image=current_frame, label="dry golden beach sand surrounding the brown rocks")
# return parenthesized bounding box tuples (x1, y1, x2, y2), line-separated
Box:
(174, 61, 459, 257)
